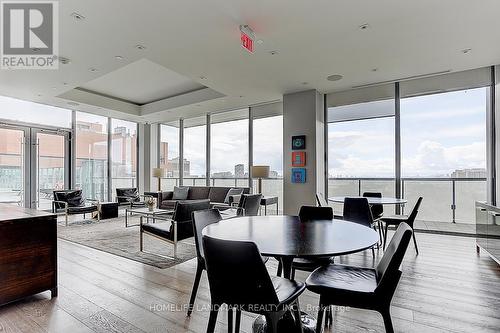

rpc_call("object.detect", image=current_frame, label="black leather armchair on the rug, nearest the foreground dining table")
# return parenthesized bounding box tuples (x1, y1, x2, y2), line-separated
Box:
(139, 199, 210, 258)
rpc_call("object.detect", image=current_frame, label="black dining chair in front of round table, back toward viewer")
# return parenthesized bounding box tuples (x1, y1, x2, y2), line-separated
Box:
(203, 236, 305, 333)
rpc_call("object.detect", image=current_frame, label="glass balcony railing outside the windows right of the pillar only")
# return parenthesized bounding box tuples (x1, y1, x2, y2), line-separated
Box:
(328, 178, 486, 224)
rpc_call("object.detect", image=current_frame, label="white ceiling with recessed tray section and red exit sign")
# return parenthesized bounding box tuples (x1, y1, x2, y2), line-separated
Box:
(0, 0, 500, 121)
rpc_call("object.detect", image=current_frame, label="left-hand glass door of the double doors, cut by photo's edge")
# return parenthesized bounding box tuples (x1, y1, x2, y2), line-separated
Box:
(0, 126, 29, 206)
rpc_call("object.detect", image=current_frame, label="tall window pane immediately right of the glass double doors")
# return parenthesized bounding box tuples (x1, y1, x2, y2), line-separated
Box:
(75, 112, 108, 201)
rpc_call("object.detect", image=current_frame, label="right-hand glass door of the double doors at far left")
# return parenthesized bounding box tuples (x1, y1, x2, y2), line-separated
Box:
(31, 129, 69, 210)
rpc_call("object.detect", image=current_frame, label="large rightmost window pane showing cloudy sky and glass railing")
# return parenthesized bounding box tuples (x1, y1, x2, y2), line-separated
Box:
(401, 88, 489, 223)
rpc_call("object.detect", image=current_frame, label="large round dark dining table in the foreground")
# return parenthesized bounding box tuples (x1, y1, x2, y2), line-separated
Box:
(203, 215, 379, 279)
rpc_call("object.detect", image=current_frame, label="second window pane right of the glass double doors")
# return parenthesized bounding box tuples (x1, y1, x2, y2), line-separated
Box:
(110, 119, 137, 198)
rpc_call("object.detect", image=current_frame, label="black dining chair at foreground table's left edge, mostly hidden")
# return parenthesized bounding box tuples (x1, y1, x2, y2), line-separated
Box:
(187, 209, 222, 316)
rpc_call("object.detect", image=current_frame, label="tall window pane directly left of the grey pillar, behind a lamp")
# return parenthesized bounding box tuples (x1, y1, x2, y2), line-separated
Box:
(253, 116, 283, 210)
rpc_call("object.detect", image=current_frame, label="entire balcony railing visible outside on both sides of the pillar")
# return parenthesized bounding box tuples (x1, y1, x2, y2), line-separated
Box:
(162, 177, 486, 224)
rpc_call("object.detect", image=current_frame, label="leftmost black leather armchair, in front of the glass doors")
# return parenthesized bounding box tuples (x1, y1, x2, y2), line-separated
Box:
(52, 190, 100, 226)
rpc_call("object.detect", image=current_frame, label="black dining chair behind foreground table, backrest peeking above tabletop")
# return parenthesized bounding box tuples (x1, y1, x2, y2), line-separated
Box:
(290, 206, 333, 280)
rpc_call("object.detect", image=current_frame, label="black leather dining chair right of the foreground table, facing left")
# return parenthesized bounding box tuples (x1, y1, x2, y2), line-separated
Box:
(306, 223, 412, 333)
